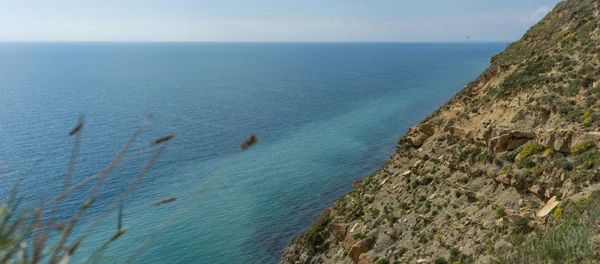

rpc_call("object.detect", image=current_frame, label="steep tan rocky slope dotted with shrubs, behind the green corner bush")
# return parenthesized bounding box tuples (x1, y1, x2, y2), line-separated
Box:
(281, 0, 600, 263)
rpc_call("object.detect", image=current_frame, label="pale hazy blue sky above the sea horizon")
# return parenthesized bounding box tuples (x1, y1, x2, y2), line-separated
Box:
(0, 0, 559, 41)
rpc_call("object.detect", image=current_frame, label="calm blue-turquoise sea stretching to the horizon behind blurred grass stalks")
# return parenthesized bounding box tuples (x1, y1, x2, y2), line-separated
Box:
(0, 43, 504, 263)
